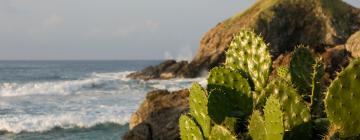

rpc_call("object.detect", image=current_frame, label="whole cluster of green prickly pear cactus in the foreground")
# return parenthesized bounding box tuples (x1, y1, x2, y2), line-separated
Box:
(179, 29, 360, 140)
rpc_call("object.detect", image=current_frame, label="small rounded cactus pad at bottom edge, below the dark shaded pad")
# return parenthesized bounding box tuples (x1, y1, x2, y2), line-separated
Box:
(209, 125, 236, 140)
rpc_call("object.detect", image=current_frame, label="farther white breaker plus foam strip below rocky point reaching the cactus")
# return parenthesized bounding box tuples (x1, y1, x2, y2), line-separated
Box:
(0, 71, 206, 97)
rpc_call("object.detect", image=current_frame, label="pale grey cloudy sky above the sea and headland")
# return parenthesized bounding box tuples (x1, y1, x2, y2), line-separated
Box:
(0, 0, 360, 60)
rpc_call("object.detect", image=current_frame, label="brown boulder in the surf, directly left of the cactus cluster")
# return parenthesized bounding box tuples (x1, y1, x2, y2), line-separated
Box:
(123, 90, 189, 140)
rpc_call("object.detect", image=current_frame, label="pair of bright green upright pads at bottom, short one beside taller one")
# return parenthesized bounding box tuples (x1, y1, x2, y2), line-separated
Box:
(249, 95, 285, 140)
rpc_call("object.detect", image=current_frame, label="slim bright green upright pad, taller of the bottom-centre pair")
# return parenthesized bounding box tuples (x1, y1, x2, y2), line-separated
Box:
(264, 95, 285, 140)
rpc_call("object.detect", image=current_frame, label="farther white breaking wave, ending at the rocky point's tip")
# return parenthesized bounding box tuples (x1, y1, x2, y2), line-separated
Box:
(0, 72, 131, 96)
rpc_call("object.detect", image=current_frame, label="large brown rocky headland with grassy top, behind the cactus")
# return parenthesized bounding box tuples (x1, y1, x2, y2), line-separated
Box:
(130, 0, 360, 79)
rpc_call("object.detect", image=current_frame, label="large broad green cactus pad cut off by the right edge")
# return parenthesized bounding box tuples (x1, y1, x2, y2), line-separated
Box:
(325, 59, 360, 138)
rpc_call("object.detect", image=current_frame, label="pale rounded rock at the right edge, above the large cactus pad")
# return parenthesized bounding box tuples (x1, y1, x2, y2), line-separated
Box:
(345, 31, 360, 58)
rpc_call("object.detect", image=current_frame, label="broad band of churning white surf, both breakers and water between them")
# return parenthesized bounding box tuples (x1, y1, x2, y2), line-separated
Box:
(0, 72, 206, 133)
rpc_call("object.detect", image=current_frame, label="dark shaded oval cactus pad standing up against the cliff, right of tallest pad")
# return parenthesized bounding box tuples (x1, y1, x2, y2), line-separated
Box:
(290, 45, 315, 95)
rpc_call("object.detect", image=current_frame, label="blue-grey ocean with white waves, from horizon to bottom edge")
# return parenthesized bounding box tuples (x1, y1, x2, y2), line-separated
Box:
(0, 61, 204, 140)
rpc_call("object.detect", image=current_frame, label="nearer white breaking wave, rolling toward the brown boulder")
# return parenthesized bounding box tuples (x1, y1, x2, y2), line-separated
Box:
(0, 107, 131, 133)
